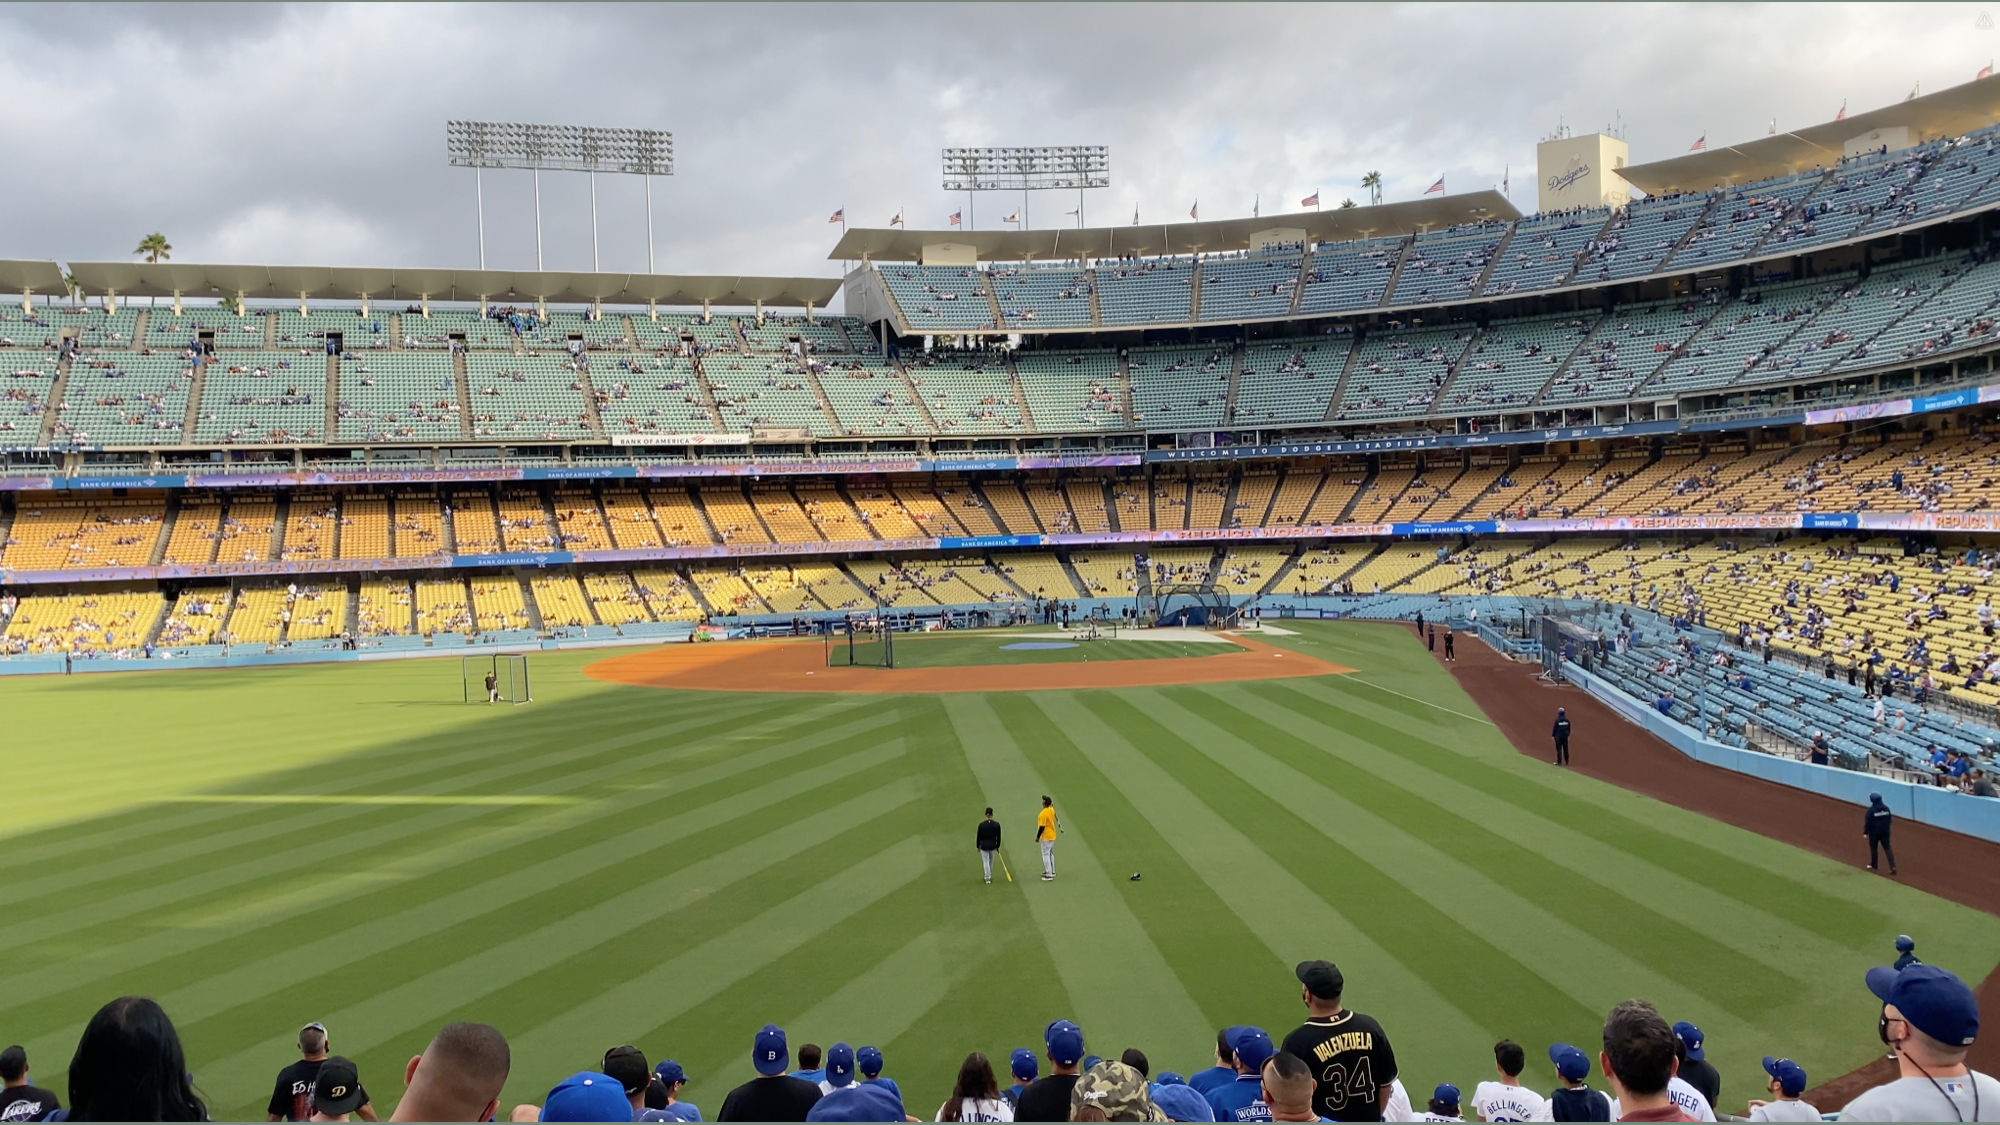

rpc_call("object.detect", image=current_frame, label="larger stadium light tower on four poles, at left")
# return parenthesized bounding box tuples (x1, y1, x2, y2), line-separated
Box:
(444, 120, 674, 272)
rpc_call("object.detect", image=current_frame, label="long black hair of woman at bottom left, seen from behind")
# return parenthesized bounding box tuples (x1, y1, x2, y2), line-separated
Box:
(68, 997, 208, 1121)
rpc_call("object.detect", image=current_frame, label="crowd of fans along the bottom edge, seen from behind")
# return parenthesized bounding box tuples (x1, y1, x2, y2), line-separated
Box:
(0, 949, 2000, 1121)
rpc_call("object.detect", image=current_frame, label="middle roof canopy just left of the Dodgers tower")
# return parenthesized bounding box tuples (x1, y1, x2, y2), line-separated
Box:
(828, 190, 1520, 262)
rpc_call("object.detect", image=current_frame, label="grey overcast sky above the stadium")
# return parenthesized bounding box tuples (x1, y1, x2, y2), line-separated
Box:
(0, 0, 2000, 276)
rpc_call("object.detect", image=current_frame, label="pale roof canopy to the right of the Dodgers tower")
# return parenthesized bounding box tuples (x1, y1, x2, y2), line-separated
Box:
(1618, 80, 2000, 196)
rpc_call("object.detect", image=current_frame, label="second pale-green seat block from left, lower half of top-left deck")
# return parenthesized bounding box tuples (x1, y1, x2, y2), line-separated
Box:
(52, 352, 191, 444)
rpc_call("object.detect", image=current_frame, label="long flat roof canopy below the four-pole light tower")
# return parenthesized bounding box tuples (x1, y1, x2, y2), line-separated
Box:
(62, 262, 840, 308)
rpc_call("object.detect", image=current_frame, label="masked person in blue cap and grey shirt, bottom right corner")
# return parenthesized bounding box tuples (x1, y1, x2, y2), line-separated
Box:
(1840, 965, 2000, 1121)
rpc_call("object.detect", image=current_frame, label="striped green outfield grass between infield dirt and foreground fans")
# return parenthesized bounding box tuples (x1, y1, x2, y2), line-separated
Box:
(0, 625, 2000, 1119)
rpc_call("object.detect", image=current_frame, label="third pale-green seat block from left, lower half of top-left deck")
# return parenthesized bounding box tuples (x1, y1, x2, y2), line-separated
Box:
(194, 350, 326, 444)
